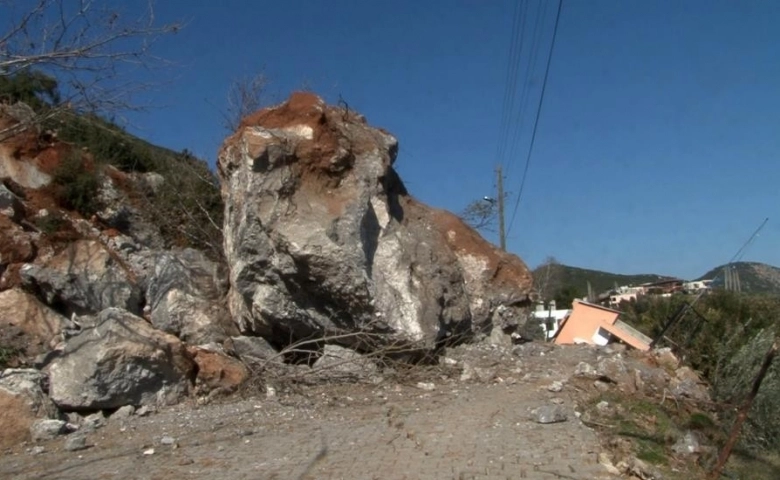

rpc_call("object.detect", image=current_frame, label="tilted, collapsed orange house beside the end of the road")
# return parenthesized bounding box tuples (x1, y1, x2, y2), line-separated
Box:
(555, 300, 652, 351)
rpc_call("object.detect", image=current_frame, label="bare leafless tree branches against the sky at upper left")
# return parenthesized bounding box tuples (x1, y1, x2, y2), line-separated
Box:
(0, 0, 181, 139)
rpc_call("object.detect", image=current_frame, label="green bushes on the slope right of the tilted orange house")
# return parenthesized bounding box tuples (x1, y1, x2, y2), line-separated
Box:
(621, 290, 780, 450)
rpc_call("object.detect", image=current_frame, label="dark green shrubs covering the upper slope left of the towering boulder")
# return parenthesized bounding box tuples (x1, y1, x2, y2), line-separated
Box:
(0, 71, 223, 258)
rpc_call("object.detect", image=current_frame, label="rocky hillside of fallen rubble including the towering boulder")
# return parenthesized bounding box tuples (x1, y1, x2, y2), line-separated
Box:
(0, 94, 534, 446)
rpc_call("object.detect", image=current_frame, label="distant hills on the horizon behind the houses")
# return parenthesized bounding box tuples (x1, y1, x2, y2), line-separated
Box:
(533, 262, 780, 298)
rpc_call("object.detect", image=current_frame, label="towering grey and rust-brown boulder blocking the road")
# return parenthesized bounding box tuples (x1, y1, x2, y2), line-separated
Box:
(218, 93, 532, 347)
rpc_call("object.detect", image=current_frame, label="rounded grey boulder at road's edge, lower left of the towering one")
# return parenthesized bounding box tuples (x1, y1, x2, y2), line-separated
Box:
(48, 308, 196, 410)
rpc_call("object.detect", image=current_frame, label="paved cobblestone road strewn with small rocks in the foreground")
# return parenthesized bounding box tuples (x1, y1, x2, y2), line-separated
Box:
(0, 344, 613, 480)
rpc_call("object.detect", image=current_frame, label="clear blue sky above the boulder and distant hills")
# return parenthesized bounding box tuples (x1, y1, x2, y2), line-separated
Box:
(119, 0, 780, 277)
